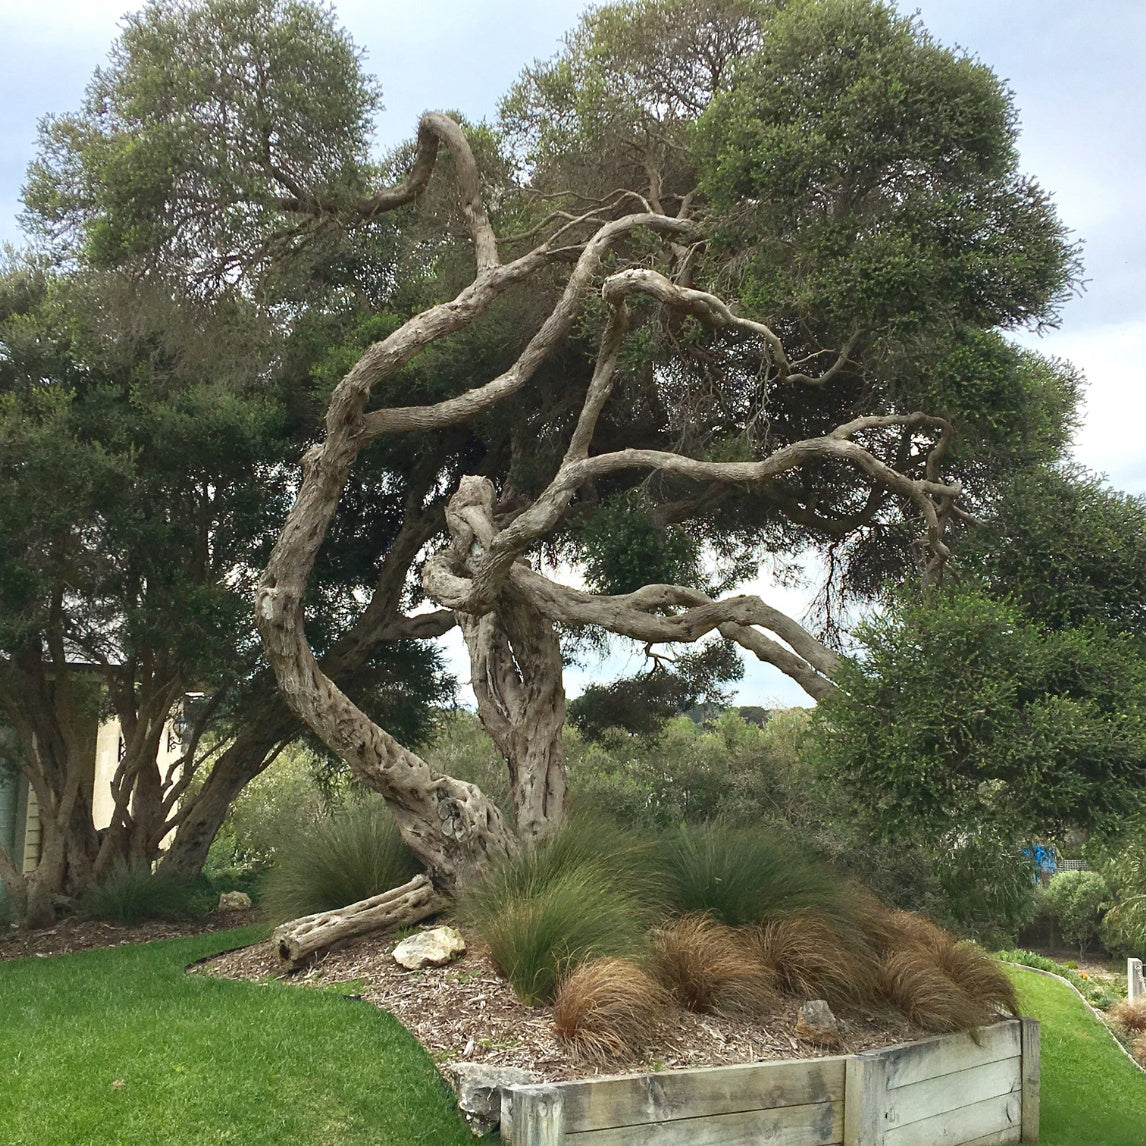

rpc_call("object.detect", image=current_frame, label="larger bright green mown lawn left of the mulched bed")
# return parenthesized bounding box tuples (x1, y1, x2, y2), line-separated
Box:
(0, 928, 472, 1146)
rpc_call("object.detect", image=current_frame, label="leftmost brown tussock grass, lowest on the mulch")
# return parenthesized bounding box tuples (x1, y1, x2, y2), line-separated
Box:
(554, 958, 673, 1062)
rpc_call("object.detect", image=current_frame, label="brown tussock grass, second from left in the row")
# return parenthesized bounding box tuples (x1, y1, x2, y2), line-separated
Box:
(651, 915, 776, 1017)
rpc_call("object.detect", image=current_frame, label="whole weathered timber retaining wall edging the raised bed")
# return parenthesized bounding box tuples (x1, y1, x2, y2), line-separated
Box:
(501, 1018, 1039, 1146)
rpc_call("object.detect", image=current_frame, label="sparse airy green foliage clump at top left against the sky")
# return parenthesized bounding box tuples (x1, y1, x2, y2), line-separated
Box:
(25, 0, 379, 288)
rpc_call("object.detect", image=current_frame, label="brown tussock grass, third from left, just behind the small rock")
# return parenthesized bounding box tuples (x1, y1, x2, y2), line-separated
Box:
(754, 913, 879, 1005)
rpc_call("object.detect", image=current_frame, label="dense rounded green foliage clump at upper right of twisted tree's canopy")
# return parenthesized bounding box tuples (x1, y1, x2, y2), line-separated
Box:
(696, 0, 1070, 345)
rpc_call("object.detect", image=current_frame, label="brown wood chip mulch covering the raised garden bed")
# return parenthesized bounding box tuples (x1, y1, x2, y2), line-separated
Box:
(191, 928, 928, 1082)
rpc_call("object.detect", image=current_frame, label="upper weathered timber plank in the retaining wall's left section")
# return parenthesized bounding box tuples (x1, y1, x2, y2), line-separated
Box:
(559, 1055, 845, 1133)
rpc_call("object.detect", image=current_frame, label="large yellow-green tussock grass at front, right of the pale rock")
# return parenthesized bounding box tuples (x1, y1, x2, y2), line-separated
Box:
(458, 817, 658, 1003)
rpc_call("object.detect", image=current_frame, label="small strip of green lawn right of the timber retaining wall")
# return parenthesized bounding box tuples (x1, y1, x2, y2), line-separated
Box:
(1007, 967, 1146, 1146)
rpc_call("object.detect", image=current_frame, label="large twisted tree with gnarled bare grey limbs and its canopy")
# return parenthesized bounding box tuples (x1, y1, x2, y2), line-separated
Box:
(13, 0, 1074, 912)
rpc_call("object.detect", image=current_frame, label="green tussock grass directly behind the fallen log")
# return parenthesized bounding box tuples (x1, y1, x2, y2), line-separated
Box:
(262, 799, 422, 923)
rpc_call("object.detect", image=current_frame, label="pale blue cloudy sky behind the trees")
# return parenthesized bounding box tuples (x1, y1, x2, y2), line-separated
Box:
(0, 0, 1146, 705)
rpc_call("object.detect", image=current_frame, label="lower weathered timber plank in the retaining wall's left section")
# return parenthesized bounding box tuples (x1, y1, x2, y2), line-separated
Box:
(565, 1101, 843, 1146)
